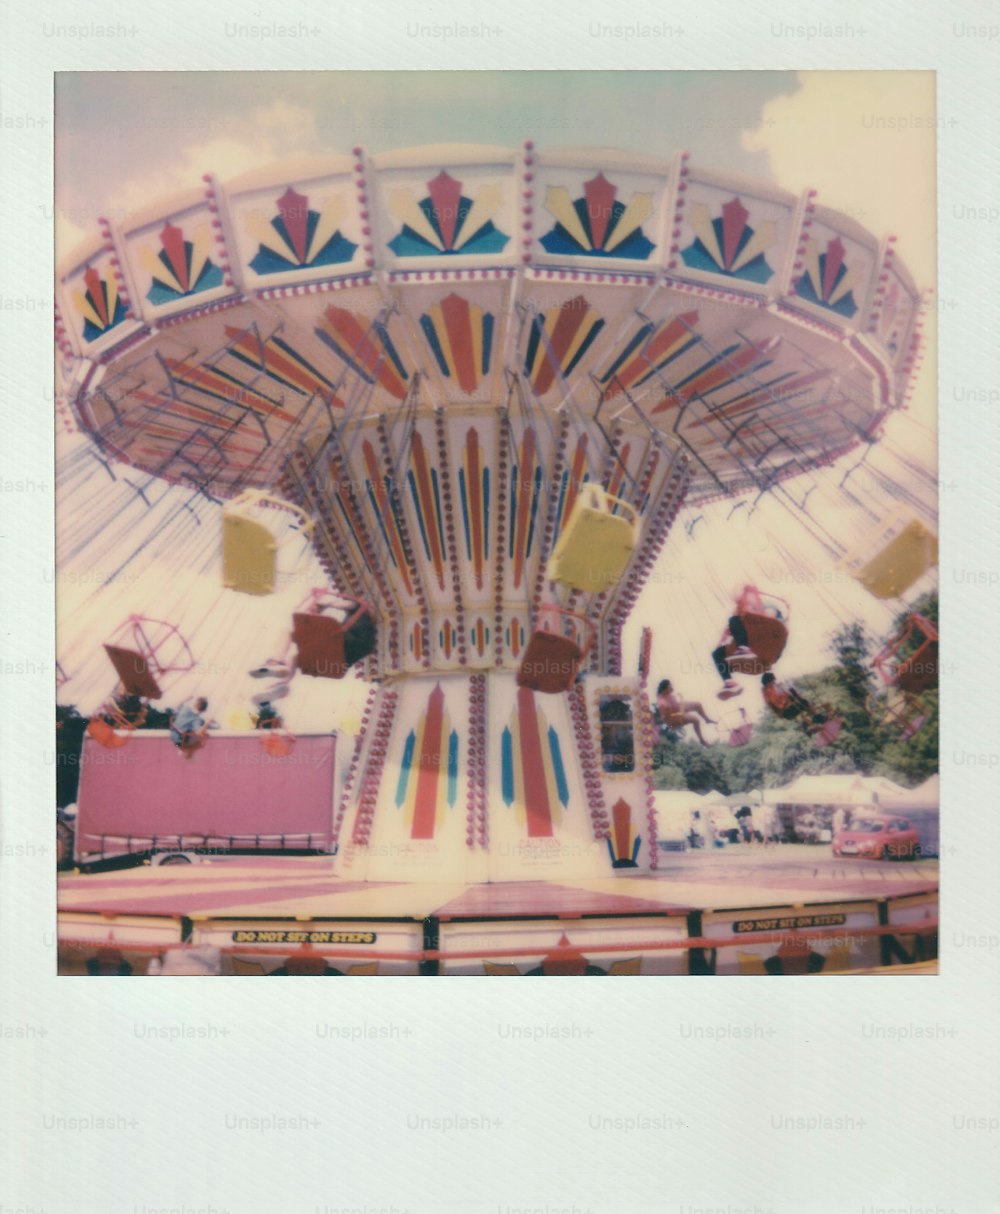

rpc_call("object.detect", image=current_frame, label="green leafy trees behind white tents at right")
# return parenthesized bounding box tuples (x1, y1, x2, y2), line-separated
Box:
(653, 594, 938, 794)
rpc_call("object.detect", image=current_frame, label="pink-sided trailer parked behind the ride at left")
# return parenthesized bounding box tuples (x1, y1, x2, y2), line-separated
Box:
(73, 730, 337, 869)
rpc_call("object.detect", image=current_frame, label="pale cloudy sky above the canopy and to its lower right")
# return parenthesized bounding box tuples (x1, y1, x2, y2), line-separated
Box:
(56, 72, 937, 728)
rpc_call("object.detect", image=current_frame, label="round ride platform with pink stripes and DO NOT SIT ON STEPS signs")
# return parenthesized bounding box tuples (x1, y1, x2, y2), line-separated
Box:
(58, 849, 938, 976)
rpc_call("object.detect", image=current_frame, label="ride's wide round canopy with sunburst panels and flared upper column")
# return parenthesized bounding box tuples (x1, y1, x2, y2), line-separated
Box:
(57, 143, 920, 671)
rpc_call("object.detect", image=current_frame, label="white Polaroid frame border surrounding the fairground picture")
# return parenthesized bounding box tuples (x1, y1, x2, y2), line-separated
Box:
(0, 0, 1000, 1214)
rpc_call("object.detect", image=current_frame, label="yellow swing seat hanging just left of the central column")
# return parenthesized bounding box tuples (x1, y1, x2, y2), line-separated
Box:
(222, 489, 314, 595)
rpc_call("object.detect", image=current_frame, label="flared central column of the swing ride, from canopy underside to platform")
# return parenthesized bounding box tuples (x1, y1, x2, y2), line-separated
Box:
(292, 407, 688, 881)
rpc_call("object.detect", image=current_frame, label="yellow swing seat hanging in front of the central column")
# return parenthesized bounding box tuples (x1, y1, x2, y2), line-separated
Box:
(549, 482, 640, 591)
